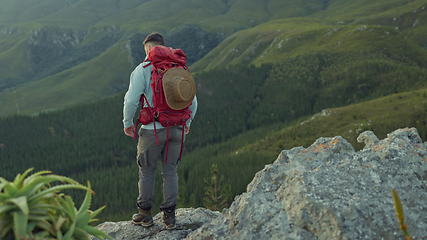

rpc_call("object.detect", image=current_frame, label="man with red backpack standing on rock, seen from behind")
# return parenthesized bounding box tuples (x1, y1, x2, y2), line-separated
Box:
(123, 33, 197, 229)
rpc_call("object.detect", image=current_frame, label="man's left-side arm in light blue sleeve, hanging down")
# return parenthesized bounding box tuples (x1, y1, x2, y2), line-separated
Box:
(123, 66, 146, 133)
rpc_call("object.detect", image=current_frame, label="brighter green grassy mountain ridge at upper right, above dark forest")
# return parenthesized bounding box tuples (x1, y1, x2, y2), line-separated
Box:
(193, 0, 427, 71)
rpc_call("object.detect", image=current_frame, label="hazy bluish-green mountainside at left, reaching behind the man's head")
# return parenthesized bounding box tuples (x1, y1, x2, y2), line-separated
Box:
(0, 0, 321, 116)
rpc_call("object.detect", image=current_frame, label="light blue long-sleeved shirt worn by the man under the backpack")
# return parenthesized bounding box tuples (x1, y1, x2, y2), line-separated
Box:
(123, 62, 197, 130)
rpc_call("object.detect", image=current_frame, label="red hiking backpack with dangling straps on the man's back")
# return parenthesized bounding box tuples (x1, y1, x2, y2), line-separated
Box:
(135, 46, 195, 161)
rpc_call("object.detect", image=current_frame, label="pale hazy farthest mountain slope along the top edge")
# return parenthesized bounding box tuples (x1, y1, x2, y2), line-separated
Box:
(0, 0, 326, 32)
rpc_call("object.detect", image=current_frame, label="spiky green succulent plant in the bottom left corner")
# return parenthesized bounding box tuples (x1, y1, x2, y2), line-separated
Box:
(0, 169, 112, 240)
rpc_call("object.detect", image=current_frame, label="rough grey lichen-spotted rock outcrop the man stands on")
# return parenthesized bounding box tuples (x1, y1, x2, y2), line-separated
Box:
(95, 128, 427, 240)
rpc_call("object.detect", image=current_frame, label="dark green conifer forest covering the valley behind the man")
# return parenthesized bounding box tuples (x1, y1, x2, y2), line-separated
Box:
(0, 59, 427, 219)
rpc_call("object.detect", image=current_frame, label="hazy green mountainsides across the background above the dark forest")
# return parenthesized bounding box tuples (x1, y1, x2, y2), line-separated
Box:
(0, 0, 427, 116)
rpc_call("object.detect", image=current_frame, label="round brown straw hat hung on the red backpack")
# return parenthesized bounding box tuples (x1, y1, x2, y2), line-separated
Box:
(163, 68, 196, 110)
